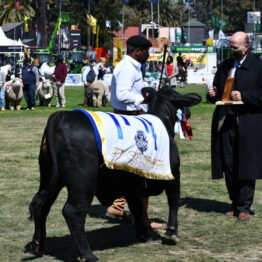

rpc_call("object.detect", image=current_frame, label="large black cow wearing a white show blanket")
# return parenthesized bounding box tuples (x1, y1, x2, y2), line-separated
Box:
(27, 87, 201, 262)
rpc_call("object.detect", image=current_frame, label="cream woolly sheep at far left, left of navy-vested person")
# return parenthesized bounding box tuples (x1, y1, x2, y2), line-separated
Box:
(4, 77, 24, 110)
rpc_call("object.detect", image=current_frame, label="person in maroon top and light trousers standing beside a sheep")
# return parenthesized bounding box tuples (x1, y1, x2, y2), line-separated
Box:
(52, 55, 67, 107)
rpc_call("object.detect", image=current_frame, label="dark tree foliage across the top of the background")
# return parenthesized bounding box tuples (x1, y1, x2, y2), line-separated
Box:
(0, 0, 260, 47)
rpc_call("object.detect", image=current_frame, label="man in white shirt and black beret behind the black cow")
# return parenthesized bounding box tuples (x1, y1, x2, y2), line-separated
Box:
(106, 35, 162, 228)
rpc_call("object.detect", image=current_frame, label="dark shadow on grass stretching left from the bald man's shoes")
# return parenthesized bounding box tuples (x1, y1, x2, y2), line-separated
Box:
(180, 197, 231, 213)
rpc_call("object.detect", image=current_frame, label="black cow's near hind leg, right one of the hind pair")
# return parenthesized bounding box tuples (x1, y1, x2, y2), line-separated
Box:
(63, 173, 98, 262)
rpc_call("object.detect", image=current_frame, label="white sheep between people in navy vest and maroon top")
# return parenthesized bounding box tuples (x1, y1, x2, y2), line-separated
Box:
(36, 79, 55, 107)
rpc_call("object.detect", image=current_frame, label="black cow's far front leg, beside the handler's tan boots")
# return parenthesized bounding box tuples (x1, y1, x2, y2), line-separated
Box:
(126, 196, 151, 242)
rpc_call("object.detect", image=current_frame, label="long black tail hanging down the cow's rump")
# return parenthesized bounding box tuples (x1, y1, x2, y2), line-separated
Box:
(29, 111, 63, 220)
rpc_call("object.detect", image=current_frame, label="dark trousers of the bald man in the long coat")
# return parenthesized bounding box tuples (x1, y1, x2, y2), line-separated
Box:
(221, 115, 256, 213)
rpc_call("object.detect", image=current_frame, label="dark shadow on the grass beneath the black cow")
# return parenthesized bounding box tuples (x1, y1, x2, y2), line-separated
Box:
(21, 205, 160, 262)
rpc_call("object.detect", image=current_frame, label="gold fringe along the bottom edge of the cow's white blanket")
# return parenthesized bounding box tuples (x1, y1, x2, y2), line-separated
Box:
(104, 161, 175, 180)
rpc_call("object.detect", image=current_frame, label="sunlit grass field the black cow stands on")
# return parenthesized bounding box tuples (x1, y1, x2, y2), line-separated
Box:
(0, 86, 262, 262)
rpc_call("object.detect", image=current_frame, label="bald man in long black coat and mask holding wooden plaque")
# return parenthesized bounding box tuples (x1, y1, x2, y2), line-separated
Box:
(207, 32, 262, 221)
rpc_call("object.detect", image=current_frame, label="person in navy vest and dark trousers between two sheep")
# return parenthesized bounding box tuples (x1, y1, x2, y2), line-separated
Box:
(22, 58, 39, 110)
